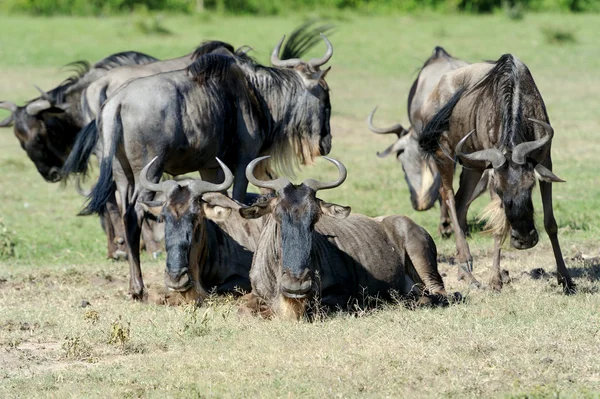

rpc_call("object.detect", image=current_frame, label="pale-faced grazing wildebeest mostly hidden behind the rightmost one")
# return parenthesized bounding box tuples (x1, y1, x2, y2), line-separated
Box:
(367, 46, 469, 237)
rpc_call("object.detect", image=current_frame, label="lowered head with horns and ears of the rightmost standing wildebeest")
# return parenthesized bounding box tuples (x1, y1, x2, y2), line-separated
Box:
(456, 118, 564, 249)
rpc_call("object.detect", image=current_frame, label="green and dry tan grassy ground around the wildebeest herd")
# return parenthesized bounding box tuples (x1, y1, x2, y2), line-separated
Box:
(0, 10, 600, 397)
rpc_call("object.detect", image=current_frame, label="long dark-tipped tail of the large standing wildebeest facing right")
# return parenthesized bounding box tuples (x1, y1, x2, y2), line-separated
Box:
(79, 105, 123, 215)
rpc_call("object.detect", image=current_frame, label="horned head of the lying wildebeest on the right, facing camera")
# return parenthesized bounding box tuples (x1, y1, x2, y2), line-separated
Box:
(240, 156, 350, 299)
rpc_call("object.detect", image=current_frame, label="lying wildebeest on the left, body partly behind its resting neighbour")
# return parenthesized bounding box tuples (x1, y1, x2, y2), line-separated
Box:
(139, 157, 262, 299)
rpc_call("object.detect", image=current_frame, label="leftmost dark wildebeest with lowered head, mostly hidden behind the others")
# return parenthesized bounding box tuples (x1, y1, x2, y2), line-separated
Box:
(0, 51, 157, 182)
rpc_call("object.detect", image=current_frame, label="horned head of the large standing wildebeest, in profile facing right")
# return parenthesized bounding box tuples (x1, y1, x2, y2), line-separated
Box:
(271, 34, 333, 163)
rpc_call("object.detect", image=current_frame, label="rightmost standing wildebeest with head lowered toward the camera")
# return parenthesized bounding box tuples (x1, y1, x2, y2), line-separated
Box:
(419, 54, 574, 292)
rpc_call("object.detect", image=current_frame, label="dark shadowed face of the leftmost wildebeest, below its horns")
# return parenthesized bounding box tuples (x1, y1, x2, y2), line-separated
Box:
(14, 107, 78, 183)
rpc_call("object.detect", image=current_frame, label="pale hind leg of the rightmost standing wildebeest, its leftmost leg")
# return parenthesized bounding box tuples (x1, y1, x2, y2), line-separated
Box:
(438, 161, 480, 287)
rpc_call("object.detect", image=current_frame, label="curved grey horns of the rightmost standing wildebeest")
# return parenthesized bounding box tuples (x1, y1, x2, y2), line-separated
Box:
(455, 118, 554, 169)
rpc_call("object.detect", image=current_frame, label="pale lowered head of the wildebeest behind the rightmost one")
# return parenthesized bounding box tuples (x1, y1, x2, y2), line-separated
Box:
(367, 107, 441, 211)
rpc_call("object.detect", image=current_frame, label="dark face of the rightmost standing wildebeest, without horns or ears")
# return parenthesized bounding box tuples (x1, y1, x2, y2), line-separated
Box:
(495, 159, 538, 249)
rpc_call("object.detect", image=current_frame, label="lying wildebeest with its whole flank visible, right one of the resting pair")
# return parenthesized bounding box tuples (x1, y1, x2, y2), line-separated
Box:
(239, 156, 446, 318)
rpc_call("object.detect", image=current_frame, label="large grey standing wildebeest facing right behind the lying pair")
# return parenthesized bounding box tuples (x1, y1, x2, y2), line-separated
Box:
(74, 36, 333, 299)
